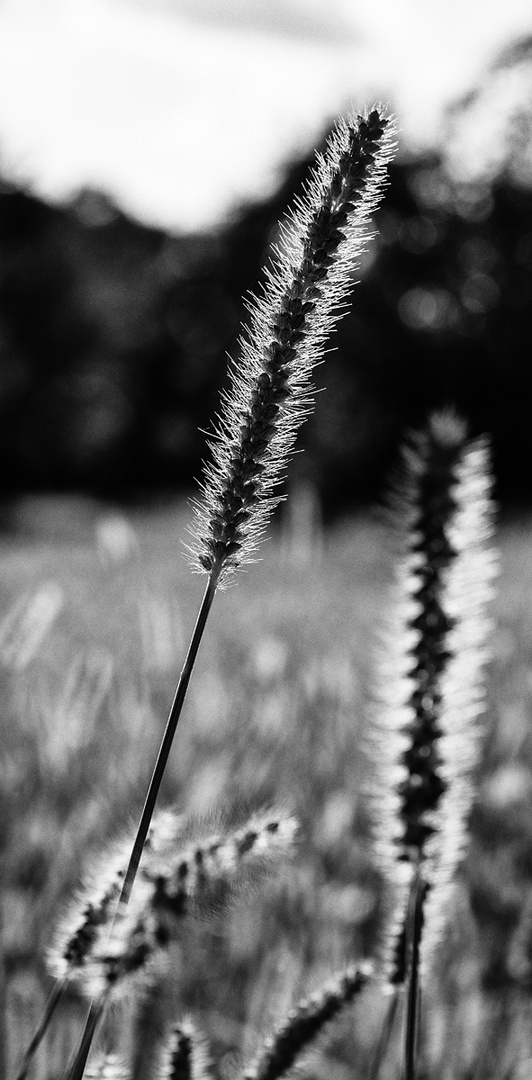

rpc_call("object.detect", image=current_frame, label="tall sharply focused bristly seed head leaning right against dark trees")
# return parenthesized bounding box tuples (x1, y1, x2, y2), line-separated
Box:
(189, 108, 394, 585)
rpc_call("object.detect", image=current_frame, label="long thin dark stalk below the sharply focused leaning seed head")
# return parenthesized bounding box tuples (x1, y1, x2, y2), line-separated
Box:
(68, 571, 219, 1080)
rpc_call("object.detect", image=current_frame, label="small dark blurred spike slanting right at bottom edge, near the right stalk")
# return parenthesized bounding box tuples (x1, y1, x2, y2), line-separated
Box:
(242, 963, 372, 1080)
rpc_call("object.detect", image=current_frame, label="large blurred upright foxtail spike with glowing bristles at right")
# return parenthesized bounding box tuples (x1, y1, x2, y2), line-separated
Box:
(368, 410, 494, 983)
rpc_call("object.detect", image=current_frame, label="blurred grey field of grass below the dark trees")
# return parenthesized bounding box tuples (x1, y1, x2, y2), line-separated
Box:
(0, 503, 532, 1080)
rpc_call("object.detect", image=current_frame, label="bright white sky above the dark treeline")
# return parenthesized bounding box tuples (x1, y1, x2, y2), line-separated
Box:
(0, 0, 532, 229)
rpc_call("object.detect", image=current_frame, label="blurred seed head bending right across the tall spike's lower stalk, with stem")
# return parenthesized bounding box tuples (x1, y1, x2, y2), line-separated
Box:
(64, 809, 298, 1080)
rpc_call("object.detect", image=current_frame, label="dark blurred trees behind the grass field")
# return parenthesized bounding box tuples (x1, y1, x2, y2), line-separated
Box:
(0, 33, 532, 512)
